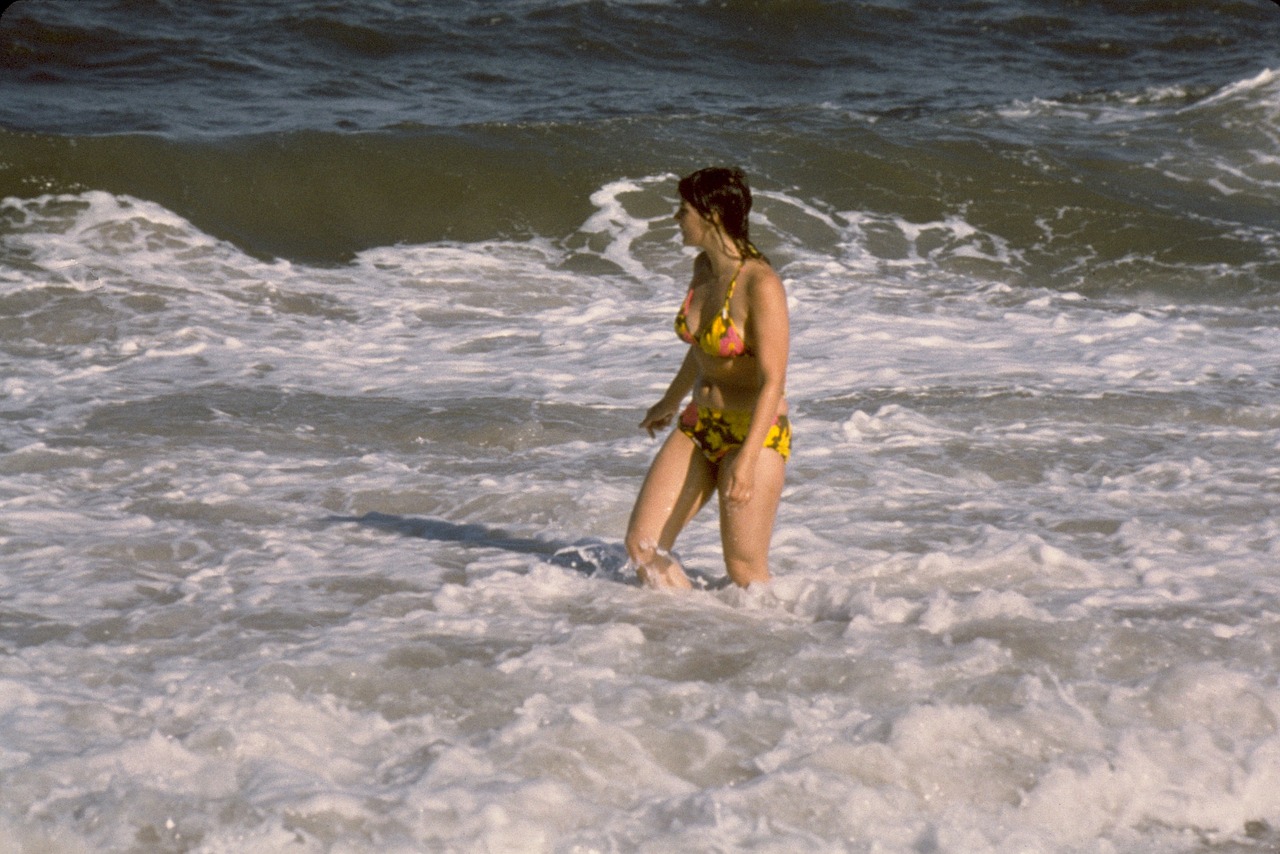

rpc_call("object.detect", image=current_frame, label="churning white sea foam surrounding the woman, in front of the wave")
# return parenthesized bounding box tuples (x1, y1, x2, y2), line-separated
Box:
(0, 188, 1280, 853)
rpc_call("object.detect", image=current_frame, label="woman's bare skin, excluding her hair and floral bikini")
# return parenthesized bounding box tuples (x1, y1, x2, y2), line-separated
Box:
(626, 202, 790, 589)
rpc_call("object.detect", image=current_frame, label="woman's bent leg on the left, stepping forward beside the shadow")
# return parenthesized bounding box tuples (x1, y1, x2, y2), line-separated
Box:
(626, 430, 716, 589)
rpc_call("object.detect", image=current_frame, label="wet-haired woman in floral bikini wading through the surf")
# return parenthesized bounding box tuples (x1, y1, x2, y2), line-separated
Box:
(626, 168, 791, 589)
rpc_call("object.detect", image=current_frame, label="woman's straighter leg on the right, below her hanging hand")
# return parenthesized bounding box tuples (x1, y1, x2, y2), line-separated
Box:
(719, 448, 787, 588)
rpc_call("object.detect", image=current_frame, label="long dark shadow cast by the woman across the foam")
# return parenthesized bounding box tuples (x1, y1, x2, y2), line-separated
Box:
(324, 512, 630, 581)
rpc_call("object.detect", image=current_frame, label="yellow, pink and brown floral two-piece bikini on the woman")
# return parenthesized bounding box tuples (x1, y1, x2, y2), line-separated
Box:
(676, 265, 791, 462)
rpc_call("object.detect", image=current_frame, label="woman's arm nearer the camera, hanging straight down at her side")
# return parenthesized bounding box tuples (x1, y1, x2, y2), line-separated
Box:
(726, 266, 791, 503)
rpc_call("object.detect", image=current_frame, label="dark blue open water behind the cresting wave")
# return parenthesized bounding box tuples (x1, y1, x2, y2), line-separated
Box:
(0, 0, 1280, 137)
